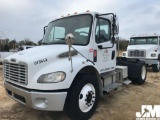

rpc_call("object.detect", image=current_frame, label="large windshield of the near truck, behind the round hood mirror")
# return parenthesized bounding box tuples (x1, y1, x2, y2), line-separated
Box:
(42, 15, 92, 45)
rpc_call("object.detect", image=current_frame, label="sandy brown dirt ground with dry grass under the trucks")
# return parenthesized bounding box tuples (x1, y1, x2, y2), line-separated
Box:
(0, 66, 160, 120)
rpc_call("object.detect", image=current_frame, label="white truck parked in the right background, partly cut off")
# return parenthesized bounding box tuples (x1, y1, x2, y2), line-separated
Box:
(122, 35, 160, 72)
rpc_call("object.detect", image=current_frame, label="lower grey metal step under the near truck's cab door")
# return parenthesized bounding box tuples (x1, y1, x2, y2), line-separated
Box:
(103, 82, 122, 93)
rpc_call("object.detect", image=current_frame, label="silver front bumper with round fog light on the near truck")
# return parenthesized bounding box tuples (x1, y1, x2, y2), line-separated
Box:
(4, 82, 67, 111)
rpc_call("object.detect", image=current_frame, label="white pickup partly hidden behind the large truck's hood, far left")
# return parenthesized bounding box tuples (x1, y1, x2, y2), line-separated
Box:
(0, 45, 34, 64)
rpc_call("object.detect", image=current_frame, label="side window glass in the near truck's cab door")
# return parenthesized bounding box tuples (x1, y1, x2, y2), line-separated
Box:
(95, 19, 110, 43)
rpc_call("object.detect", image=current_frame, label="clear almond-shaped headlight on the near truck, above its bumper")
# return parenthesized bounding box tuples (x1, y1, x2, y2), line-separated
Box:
(37, 72, 66, 83)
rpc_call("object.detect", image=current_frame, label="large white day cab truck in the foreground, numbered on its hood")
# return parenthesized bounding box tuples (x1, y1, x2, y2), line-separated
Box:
(3, 12, 147, 120)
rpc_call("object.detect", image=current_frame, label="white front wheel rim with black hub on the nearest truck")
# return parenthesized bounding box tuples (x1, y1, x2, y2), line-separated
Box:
(79, 83, 96, 112)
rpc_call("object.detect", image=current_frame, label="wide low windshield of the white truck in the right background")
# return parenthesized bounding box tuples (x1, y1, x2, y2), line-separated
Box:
(129, 37, 158, 45)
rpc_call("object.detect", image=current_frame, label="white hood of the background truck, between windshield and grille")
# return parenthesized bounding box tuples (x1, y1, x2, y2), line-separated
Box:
(127, 45, 158, 50)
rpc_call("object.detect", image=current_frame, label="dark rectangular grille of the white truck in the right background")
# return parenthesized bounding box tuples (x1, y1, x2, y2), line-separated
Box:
(128, 50, 146, 57)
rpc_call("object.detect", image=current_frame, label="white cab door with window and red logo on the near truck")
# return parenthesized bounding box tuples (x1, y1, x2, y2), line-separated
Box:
(94, 18, 116, 73)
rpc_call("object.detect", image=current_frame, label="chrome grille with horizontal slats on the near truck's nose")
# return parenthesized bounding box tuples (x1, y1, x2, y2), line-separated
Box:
(4, 63, 28, 85)
